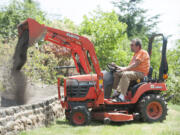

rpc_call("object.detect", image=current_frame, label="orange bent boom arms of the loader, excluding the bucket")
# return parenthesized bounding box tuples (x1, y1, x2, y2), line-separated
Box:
(44, 27, 100, 74)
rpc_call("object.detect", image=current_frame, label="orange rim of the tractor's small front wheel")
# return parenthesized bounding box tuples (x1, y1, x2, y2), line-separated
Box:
(73, 112, 85, 125)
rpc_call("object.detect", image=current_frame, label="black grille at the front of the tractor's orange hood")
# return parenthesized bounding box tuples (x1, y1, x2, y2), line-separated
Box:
(66, 79, 95, 97)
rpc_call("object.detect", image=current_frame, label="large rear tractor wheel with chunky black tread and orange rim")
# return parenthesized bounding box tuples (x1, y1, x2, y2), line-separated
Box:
(139, 94, 167, 123)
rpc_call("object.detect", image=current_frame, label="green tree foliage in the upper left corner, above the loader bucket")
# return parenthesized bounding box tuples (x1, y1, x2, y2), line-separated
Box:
(0, 0, 46, 41)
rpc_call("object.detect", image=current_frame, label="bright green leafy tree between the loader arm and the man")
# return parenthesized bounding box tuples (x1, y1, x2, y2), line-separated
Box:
(79, 10, 129, 69)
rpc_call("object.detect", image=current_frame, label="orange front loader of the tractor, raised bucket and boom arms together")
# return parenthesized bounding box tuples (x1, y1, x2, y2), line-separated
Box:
(18, 18, 103, 79)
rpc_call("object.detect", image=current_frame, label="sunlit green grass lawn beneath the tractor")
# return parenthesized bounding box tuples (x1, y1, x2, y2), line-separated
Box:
(20, 105, 180, 135)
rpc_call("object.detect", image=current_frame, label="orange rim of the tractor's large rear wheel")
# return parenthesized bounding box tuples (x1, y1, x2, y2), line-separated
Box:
(147, 102, 163, 119)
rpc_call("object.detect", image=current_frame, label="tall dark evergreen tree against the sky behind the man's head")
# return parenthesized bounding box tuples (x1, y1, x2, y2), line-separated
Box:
(113, 0, 159, 41)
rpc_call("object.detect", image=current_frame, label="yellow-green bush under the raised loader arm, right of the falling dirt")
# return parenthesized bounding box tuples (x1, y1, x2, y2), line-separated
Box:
(24, 48, 58, 84)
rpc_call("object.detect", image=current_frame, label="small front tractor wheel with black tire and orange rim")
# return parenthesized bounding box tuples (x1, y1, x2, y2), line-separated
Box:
(70, 106, 91, 126)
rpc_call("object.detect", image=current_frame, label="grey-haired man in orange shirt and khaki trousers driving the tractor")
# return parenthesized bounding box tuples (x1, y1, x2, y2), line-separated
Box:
(112, 39, 150, 102)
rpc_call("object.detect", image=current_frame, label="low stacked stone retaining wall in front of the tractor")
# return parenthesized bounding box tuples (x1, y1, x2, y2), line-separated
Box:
(0, 97, 64, 135)
